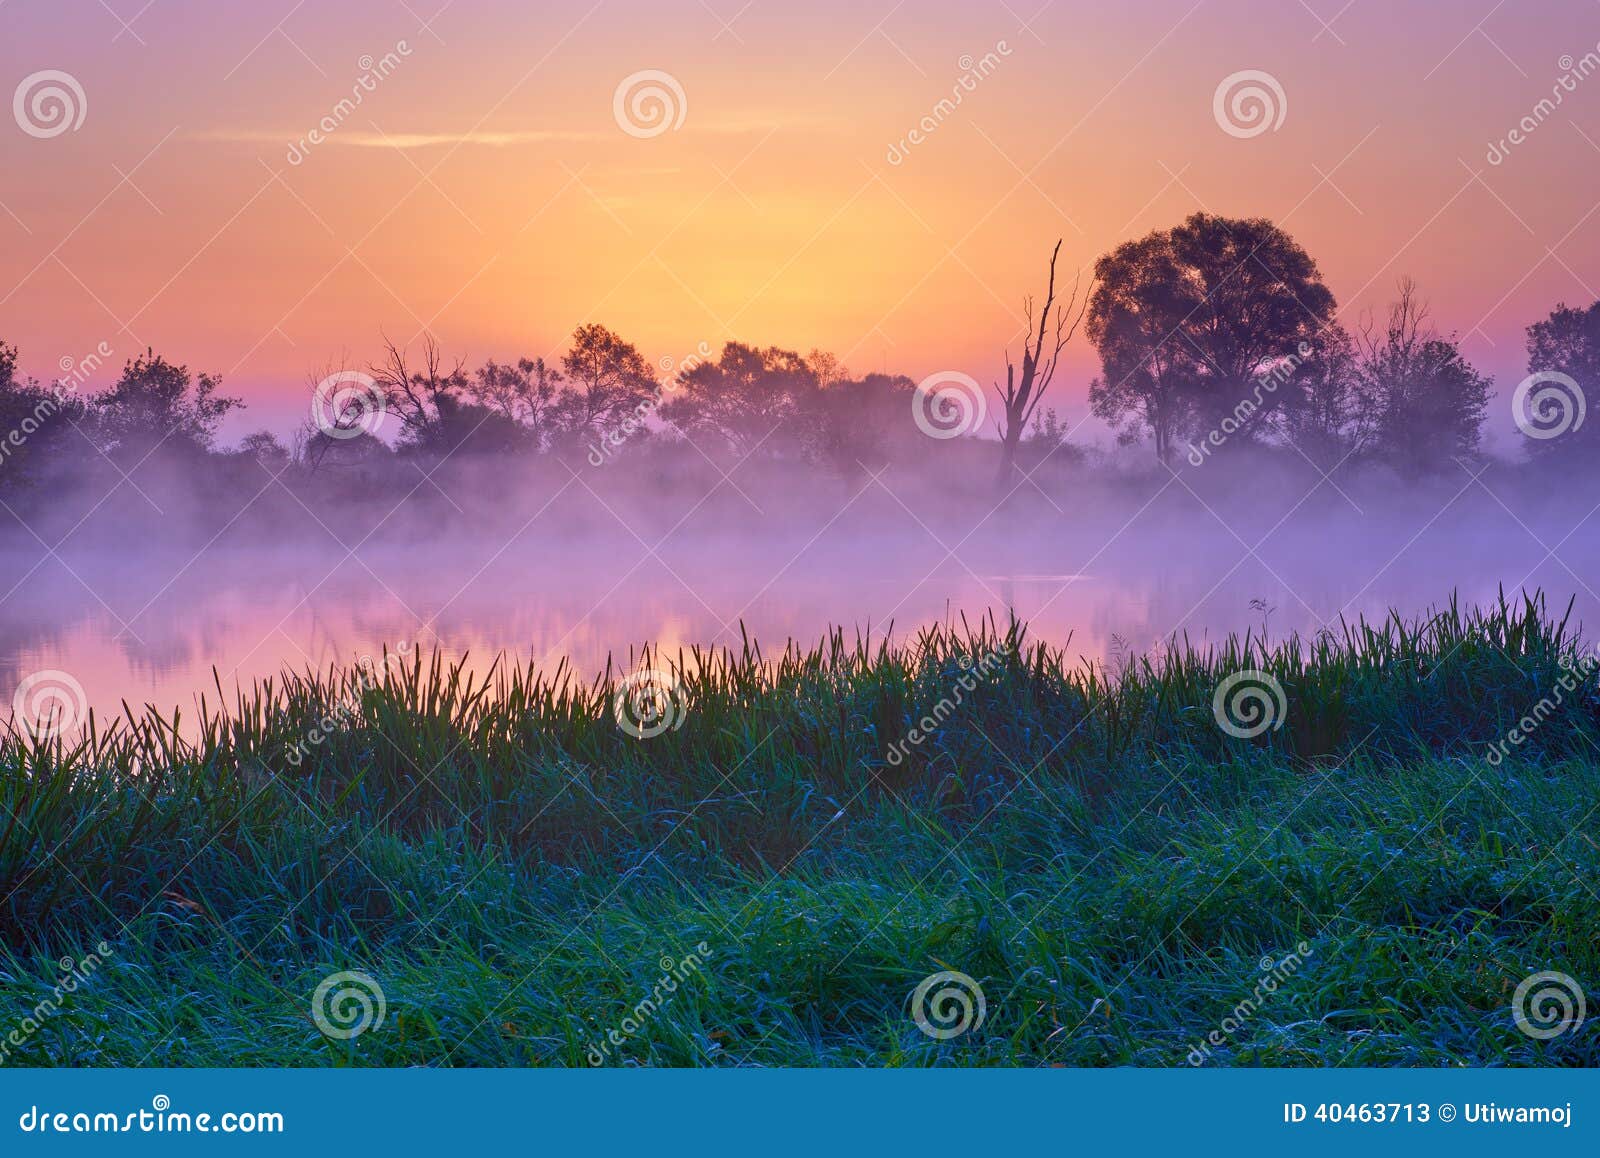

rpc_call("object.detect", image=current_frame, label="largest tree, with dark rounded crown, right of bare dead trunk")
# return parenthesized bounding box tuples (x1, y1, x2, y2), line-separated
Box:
(1088, 213, 1336, 462)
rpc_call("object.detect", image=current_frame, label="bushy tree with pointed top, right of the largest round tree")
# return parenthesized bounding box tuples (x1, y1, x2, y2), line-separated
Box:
(1358, 278, 1494, 475)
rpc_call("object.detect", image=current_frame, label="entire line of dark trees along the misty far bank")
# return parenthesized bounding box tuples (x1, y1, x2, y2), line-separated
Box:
(0, 213, 1600, 493)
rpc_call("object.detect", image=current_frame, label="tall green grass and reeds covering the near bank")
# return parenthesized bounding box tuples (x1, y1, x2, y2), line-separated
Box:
(0, 597, 1600, 1065)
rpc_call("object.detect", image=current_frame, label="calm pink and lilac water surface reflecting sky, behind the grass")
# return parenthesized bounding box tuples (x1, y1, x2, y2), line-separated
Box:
(0, 483, 1600, 729)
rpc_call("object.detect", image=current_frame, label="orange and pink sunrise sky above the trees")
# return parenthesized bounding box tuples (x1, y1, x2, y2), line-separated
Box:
(0, 0, 1600, 445)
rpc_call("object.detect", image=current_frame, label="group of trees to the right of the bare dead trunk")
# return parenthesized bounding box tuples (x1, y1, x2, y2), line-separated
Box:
(1086, 213, 1600, 475)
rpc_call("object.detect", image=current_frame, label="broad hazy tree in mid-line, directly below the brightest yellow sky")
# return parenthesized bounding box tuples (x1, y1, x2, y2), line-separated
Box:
(661, 342, 835, 457)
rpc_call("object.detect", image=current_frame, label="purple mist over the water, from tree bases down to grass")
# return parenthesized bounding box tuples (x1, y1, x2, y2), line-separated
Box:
(9, 441, 1600, 729)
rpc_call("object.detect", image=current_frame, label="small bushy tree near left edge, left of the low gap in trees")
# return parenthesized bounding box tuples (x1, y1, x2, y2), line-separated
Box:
(93, 350, 243, 461)
